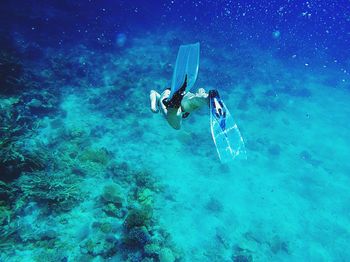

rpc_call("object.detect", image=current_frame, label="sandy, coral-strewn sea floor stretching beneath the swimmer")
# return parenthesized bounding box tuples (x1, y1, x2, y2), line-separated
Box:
(0, 31, 350, 262)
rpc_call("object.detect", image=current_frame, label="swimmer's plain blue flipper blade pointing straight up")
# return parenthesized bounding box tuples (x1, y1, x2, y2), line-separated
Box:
(169, 43, 199, 100)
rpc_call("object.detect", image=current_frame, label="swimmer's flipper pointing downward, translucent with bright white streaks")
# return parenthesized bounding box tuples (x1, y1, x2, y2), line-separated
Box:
(209, 90, 246, 163)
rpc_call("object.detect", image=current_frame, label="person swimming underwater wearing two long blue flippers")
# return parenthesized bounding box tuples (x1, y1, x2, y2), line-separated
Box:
(150, 43, 245, 162)
